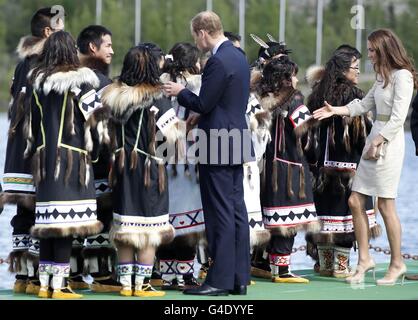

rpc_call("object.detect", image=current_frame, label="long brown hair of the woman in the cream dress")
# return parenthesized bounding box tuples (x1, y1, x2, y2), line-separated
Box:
(367, 29, 418, 88)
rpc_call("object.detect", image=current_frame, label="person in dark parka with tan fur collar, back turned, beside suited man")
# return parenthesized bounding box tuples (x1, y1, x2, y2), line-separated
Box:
(102, 44, 177, 297)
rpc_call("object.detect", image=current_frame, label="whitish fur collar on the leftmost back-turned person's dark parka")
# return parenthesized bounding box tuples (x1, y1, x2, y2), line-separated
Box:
(33, 67, 100, 95)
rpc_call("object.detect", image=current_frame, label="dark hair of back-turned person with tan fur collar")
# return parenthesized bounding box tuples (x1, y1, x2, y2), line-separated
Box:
(119, 43, 161, 86)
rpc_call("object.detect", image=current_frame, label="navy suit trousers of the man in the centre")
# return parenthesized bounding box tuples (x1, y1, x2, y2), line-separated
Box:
(199, 164, 250, 290)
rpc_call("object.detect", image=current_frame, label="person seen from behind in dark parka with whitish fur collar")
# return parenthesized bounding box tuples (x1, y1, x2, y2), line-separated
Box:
(27, 31, 110, 299)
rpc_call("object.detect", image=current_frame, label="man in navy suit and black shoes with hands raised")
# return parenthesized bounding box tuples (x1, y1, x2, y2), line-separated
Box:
(164, 11, 252, 296)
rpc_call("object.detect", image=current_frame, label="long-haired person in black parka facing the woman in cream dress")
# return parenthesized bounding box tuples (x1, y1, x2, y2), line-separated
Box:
(307, 45, 380, 278)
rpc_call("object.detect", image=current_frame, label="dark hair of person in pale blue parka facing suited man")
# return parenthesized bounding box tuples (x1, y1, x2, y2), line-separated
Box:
(163, 42, 200, 81)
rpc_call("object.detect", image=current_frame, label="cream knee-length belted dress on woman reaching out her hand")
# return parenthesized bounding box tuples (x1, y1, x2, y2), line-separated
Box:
(347, 69, 414, 198)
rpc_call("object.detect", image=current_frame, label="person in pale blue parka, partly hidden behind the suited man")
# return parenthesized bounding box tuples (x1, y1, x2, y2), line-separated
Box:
(157, 43, 205, 290)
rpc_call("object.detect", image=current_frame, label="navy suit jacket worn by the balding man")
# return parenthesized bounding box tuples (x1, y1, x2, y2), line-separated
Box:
(177, 41, 254, 165)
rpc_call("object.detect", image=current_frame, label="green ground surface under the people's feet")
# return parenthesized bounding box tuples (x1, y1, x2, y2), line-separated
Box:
(0, 261, 418, 300)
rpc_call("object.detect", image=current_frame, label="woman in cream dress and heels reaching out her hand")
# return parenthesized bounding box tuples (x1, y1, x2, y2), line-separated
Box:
(314, 29, 417, 285)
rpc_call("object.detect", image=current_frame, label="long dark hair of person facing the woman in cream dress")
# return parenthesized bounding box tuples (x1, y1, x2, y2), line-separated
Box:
(307, 45, 362, 111)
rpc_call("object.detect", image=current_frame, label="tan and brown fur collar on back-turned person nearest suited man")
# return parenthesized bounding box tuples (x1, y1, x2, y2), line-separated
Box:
(101, 81, 163, 123)
